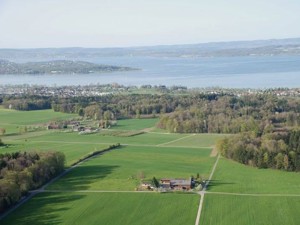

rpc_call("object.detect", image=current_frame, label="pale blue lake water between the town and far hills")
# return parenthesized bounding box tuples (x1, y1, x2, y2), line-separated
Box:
(0, 56, 300, 88)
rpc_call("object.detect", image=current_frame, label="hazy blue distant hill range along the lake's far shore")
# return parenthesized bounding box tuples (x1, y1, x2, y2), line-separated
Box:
(0, 38, 300, 61)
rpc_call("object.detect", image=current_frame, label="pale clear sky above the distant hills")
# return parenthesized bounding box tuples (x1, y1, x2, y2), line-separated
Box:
(0, 0, 300, 48)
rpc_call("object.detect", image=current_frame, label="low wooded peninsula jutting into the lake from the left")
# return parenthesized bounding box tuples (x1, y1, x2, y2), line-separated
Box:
(0, 60, 136, 74)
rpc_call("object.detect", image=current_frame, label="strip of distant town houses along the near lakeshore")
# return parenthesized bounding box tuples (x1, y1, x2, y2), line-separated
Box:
(0, 83, 300, 97)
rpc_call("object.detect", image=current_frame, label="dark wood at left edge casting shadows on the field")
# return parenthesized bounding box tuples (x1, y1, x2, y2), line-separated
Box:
(0, 152, 65, 213)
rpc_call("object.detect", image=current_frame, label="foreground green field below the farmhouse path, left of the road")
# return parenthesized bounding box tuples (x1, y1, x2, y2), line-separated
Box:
(1, 193, 199, 225)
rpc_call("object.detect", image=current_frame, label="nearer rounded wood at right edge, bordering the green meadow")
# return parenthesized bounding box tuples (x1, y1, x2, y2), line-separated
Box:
(217, 130, 300, 171)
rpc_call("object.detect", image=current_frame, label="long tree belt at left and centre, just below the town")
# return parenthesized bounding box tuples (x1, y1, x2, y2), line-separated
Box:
(2, 94, 221, 119)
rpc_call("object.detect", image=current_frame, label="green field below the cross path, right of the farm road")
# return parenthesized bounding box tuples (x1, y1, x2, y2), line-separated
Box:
(200, 194, 300, 225)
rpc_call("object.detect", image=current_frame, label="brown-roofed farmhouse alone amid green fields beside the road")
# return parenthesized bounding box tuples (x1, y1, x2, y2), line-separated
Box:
(160, 178, 192, 190)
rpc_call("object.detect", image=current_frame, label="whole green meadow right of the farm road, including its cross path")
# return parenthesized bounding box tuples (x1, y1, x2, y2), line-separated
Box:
(200, 158, 300, 225)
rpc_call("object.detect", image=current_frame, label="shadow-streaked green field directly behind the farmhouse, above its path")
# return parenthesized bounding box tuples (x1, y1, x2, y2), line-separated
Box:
(48, 146, 216, 191)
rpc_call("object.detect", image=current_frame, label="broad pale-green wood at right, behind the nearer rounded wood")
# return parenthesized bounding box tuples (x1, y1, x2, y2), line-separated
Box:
(157, 95, 300, 135)
